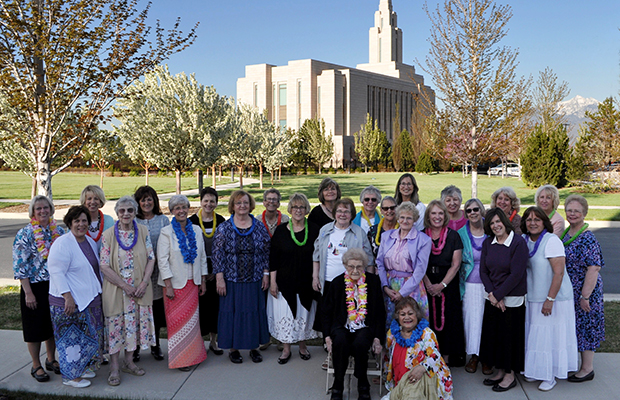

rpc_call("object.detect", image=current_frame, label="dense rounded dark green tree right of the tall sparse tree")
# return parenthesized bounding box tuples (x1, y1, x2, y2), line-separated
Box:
(521, 124, 569, 187)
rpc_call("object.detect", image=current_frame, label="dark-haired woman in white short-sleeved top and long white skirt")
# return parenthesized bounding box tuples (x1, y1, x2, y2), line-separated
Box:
(521, 207, 579, 391)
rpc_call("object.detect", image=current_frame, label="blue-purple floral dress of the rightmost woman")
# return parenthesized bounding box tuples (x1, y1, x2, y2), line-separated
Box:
(562, 231, 605, 351)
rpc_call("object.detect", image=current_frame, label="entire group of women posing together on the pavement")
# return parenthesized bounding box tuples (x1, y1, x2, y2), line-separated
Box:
(14, 178, 604, 400)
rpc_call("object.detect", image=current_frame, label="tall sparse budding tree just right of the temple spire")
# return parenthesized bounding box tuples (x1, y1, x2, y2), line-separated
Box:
(422, 0, 530, 197)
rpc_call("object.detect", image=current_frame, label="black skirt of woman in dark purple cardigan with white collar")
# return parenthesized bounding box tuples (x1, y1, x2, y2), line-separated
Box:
(480, 300, 525, 372)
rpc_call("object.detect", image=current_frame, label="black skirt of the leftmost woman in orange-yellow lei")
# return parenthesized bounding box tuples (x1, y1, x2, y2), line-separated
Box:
(19, 281, 54, 343)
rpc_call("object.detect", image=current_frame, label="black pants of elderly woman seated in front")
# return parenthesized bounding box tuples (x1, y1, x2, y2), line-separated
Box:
(330, 328, 373, 390)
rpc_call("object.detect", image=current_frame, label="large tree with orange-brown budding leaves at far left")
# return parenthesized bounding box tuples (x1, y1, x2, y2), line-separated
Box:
(0, 0, 196, 198)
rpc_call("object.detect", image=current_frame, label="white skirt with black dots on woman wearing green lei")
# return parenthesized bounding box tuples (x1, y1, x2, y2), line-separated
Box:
(267, 292, 319, 343)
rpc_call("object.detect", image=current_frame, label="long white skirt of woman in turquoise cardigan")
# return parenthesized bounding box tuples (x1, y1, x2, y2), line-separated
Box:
(463, 282, 485, 355)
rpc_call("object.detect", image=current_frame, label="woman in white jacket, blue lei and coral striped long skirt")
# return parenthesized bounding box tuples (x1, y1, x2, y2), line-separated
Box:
(157, 194, 208, 371)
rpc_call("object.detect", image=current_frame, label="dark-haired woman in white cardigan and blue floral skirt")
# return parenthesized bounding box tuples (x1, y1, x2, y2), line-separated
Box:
(47, 206, 104, 388)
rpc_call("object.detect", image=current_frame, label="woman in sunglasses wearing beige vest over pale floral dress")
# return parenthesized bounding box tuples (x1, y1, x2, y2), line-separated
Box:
(100, 196, 155, 386)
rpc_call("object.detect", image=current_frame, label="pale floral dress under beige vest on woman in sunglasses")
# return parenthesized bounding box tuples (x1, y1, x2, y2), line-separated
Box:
(100, 230, 155, 354)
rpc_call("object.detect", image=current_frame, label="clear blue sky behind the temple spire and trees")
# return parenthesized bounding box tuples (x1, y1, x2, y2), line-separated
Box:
(147, 0, 620, 101)
